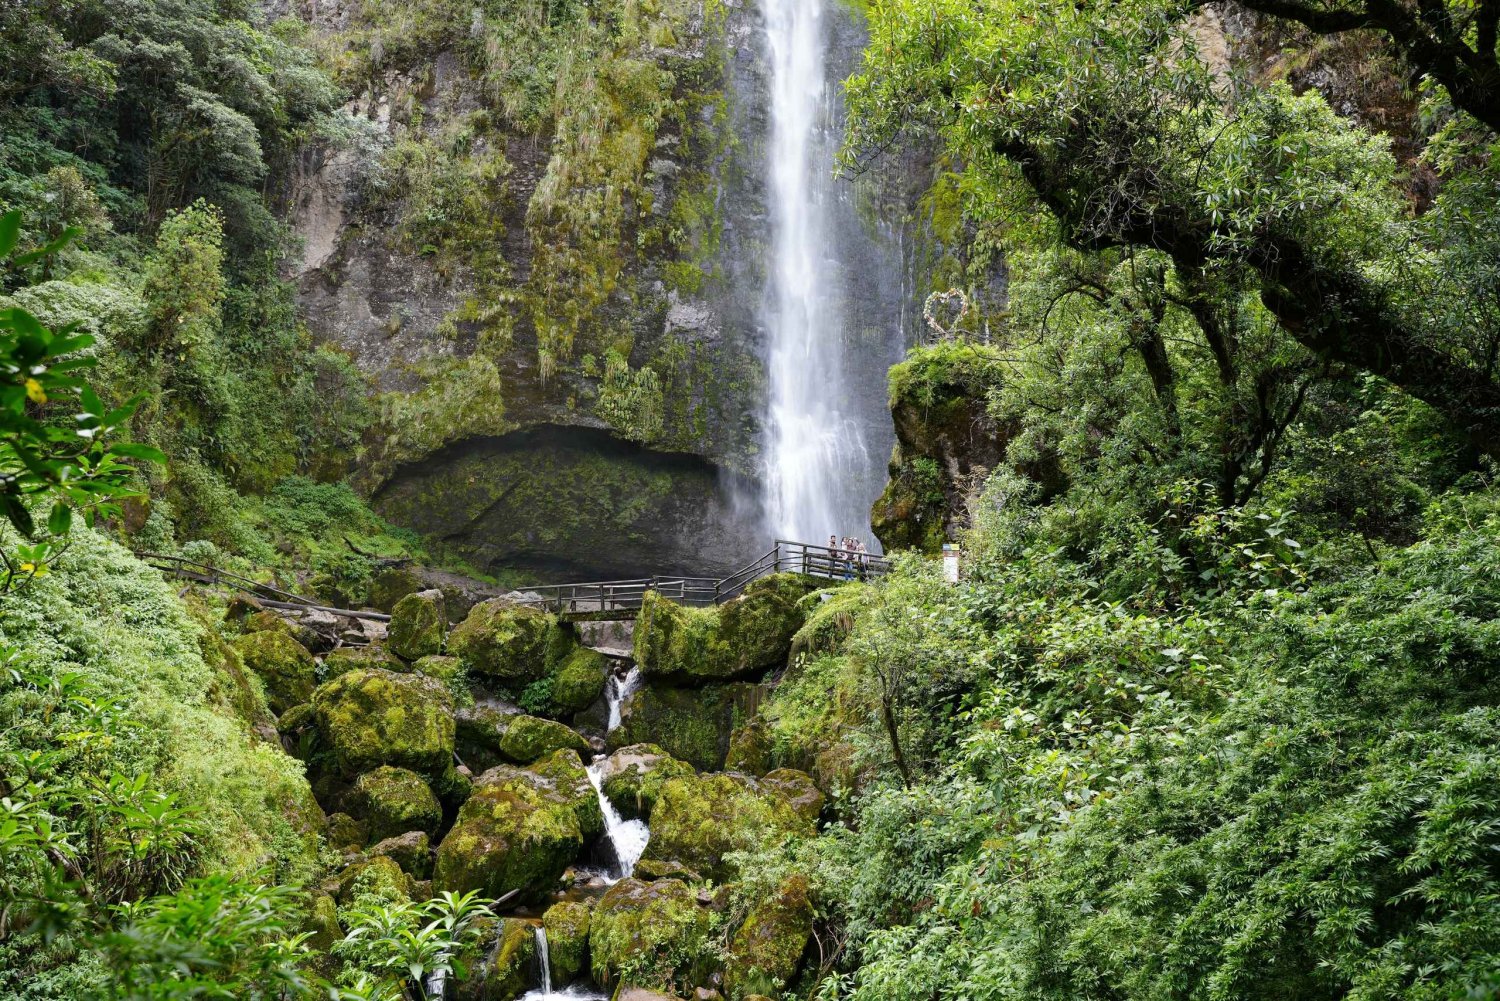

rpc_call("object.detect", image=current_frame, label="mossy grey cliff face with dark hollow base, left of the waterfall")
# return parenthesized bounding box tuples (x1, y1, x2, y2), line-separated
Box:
(269, 0, 786, 572)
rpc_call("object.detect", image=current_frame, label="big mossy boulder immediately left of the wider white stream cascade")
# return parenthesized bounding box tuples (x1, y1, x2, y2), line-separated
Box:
(432, 750, 605, 900)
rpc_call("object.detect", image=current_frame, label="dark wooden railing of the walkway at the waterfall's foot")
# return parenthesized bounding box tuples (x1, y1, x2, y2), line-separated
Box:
(521, 539, 891, 618)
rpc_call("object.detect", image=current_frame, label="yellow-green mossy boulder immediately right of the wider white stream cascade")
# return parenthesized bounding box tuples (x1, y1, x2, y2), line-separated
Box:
(645, 773, 816, 882)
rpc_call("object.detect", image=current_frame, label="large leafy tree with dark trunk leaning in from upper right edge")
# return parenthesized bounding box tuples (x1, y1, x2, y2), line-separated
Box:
(846, 0, 1500, 455)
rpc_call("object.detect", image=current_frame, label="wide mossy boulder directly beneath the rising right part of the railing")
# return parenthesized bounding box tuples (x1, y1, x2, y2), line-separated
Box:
(635, 573, 807, 683)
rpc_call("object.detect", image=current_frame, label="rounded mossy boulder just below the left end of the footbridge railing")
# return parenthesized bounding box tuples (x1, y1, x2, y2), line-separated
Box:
(449, 599, 576, 686)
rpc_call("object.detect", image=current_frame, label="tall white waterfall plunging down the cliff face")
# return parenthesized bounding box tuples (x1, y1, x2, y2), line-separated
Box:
(761, 0, 872, 542)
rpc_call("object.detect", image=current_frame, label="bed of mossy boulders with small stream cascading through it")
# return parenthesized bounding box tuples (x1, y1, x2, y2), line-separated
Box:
(234, 576, 824, 1001)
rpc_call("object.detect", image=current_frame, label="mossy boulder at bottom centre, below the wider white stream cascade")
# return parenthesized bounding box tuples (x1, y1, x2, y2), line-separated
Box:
(588, 879, 714, 989)
